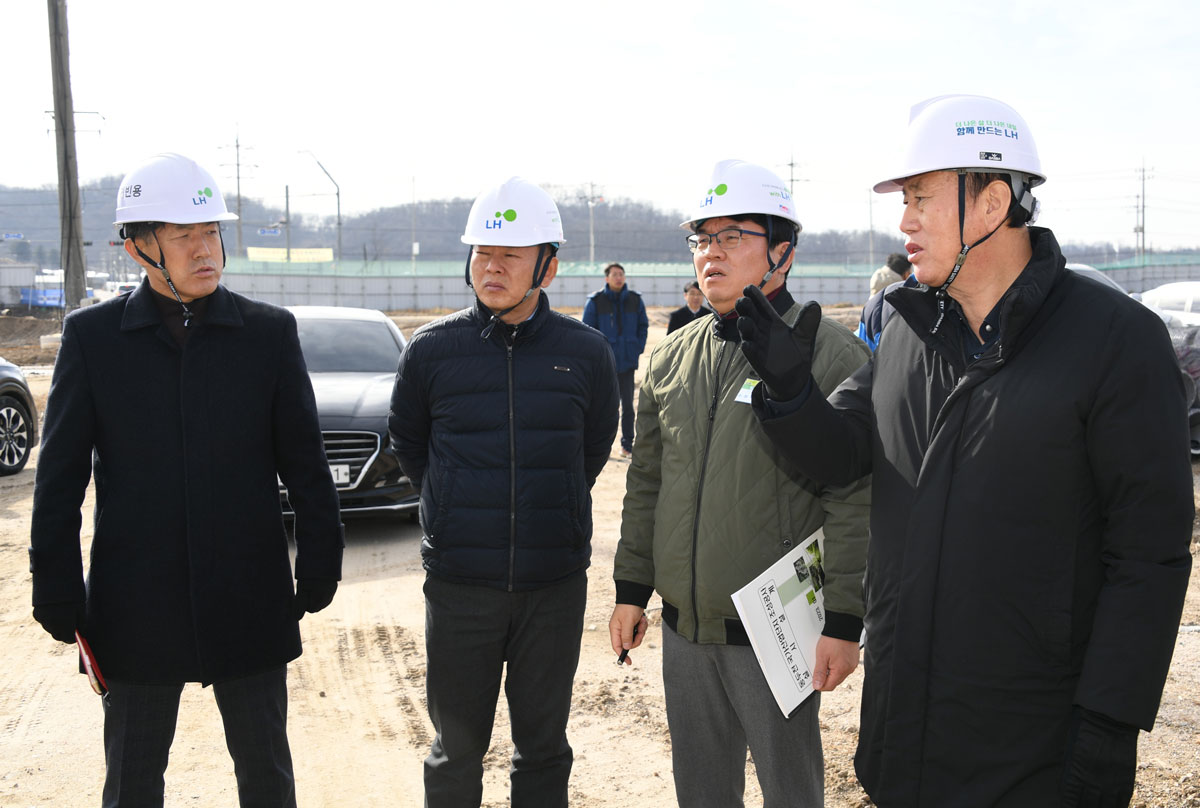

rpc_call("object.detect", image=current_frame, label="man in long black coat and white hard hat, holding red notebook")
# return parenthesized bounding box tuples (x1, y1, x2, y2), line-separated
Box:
(30, 154, 342, 807)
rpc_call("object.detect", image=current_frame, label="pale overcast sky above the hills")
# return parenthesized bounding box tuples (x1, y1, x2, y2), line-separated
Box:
(7, 0, 1200, 249)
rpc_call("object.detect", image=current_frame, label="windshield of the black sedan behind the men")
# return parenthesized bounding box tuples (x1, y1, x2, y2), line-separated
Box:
(296, 318, 400, 373)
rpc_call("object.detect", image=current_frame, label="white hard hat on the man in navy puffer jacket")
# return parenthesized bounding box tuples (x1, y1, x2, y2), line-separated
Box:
(462, 176, 566, 247)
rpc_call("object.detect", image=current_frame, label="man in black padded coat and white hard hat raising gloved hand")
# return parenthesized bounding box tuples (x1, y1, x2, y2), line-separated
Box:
(738, 95, 1194, 808)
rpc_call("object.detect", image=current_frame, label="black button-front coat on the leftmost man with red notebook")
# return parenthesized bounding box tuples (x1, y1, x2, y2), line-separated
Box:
(30, 281, 343, 684)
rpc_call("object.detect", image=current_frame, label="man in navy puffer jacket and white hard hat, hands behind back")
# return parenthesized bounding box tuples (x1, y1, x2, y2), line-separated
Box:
(389, 178, 618, 808)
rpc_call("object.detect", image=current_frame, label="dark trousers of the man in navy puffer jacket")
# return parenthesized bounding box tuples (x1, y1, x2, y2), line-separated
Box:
(425, 571, 587, 808)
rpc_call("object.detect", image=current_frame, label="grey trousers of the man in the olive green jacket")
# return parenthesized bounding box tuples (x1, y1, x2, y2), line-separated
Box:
(662, 627, 824, 808)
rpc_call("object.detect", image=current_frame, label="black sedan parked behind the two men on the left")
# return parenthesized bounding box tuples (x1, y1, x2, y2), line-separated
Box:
(280, 306, 420, 515)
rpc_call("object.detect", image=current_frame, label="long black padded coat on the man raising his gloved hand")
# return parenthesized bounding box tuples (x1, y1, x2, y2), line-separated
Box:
(756, 228, 1194, 808)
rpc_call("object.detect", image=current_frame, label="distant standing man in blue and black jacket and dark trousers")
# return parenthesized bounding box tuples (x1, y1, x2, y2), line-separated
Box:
(583, 264, 650, 457)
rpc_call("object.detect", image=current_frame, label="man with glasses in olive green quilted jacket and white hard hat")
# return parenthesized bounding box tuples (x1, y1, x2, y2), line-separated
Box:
(608, 160, 869, 808)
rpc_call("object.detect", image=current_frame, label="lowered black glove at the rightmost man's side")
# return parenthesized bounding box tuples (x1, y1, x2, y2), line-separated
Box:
(1062, 707, 1138, 808)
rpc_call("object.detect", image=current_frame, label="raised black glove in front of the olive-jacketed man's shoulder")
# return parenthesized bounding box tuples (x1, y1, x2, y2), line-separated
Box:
(733, 286, 821, 401)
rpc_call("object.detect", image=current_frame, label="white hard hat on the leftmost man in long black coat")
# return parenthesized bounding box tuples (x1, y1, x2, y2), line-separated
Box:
(113, 152, 238, 225)
